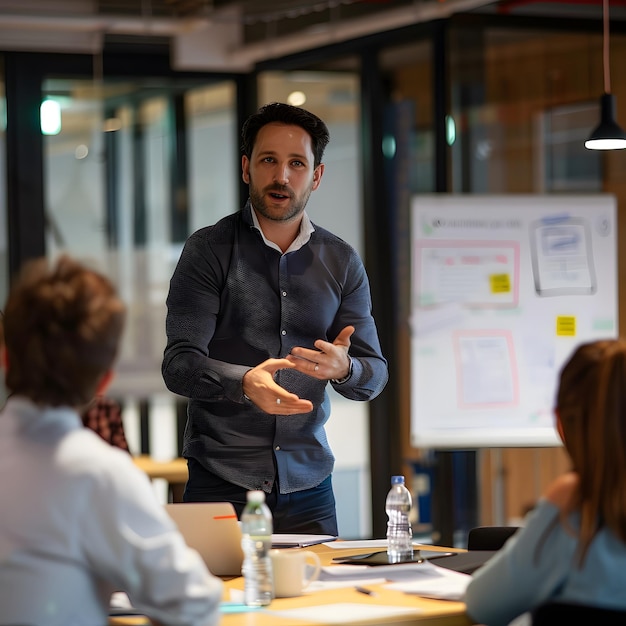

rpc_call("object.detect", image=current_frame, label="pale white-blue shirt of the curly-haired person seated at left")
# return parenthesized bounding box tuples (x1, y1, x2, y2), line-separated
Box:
(0, 396, 223, 626)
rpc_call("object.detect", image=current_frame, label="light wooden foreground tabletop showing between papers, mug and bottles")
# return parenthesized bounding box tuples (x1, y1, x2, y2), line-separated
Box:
(110, 544, 475, 626)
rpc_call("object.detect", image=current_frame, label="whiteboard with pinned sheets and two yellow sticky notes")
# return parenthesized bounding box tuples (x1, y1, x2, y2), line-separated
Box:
(410, 194, 618, 449)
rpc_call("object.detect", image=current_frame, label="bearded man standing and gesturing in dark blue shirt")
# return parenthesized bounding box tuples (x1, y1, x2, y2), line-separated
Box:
(162, 103, 387, 535)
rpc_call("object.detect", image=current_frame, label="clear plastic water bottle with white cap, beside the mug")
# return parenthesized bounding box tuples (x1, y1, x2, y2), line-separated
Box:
(241, 491, 274, 606)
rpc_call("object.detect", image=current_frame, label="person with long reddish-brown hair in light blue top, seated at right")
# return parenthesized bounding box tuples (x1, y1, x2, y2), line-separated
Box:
(465, 339, 626, 626)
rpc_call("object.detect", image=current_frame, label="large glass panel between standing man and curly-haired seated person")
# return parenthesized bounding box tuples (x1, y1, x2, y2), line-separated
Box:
(44, 79, 238, 458)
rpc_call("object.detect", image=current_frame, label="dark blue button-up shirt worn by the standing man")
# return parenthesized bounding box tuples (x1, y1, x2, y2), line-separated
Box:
(162, 202, 387, 493)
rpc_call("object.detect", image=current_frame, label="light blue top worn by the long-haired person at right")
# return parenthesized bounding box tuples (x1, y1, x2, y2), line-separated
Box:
(465, 500, 626, 626)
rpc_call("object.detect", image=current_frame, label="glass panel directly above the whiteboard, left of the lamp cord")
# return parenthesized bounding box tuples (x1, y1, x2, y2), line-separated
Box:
(450, 27, 608, 193)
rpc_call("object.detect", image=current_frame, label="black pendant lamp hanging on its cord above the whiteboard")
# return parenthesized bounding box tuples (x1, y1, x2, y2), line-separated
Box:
(585, 0, 626, 150)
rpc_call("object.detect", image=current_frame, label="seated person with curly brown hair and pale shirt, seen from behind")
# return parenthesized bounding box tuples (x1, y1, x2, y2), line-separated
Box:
(0, 257, 222, 626)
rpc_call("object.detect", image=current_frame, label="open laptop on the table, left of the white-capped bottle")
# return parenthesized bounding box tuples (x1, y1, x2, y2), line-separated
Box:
(165, 502, 243, 576)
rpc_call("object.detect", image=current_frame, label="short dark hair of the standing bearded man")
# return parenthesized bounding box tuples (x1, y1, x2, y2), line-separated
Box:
(241, 102, 330, 167)
